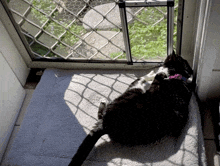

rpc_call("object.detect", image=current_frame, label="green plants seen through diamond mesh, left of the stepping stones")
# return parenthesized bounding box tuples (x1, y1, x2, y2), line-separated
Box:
(27, 0, 86, 57)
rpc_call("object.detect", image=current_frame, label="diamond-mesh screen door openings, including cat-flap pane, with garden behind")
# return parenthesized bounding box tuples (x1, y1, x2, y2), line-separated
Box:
(7, 0, 178, 62)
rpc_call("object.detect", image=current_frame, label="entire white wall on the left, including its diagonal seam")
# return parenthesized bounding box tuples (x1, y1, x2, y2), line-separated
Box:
(0, 20, 29, 161)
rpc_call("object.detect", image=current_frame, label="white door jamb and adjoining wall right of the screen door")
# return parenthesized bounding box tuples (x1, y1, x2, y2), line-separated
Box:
(181, 0, 220, 101)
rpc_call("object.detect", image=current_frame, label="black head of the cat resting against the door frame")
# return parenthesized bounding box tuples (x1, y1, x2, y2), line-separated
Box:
(164, 52, 193, 78)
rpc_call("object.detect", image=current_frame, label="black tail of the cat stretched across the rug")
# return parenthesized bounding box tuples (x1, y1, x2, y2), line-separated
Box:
(69, 120, 106, 166)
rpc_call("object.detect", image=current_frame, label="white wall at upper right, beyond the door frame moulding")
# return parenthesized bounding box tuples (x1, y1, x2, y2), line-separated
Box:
(195, 0, 220, 101)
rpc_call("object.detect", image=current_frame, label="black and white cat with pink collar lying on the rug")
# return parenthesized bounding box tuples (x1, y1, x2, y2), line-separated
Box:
(69, 53, 193, 166)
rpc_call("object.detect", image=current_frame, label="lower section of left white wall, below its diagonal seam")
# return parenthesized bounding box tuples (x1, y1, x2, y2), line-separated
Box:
(0, 52, 25, 159)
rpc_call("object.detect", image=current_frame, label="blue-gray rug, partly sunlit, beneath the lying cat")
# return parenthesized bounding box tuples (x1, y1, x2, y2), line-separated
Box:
(5, 69, 206, 166)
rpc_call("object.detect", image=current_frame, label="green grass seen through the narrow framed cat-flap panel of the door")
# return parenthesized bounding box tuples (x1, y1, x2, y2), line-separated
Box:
(128, 3, 177, 59)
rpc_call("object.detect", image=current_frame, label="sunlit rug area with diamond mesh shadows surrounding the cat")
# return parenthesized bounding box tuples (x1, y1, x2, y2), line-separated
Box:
(64, 71, 198, 165)
